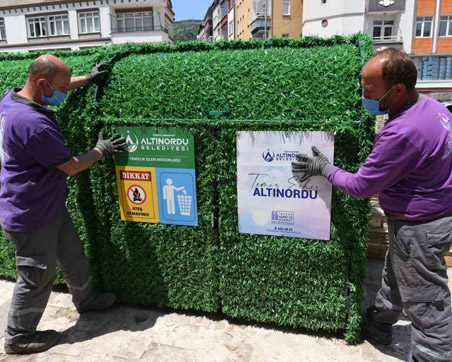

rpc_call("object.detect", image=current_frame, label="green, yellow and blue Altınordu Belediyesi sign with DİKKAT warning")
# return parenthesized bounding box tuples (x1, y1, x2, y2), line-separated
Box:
(112, 127, 198, 226)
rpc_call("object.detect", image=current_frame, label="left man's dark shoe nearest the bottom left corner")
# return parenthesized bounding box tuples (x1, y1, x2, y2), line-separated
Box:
(5, 330, 60, 354)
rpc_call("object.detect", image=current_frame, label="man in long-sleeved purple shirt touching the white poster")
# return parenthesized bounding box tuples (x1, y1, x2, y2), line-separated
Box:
(292, 49, 452, 362)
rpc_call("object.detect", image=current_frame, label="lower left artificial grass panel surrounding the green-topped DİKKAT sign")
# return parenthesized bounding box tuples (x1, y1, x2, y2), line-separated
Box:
(91, 120, 219, 312)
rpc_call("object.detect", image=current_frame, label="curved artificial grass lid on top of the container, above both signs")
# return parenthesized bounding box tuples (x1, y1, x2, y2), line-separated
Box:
(100, 44, 361, 122)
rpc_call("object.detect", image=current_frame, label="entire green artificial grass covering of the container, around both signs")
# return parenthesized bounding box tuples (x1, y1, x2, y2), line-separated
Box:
(0, 35, 373, 341)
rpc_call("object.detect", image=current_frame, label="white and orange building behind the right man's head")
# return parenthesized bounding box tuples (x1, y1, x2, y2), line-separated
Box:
(303, 0, 452, 102)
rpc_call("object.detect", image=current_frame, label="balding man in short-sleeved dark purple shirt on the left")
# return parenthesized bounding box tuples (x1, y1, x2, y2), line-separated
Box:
(0, 55, 126, 354)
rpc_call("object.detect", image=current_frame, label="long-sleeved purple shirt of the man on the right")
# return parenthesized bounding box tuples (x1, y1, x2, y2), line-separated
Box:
(328, 96, 452, 219)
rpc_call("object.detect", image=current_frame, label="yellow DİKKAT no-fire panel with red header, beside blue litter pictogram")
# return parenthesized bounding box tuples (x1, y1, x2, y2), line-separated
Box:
(116, 166, 158, 223)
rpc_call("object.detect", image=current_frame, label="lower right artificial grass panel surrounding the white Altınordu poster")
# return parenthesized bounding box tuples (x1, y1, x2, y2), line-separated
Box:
(217, 119, 372, 342)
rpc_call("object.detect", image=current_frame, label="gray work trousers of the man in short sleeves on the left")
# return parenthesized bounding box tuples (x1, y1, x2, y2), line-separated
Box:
(4, 210, 96, 344)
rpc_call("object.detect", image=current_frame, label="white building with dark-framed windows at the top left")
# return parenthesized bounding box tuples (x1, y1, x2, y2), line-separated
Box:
(0, 0, 175, 52)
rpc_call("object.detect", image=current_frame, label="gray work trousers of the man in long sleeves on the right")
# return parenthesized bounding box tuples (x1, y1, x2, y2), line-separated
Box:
(373, 216, 452, 362)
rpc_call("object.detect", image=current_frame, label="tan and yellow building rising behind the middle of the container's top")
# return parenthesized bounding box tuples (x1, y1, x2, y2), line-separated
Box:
(200, 0, 303, 41)
